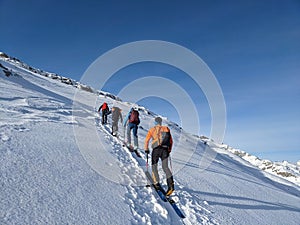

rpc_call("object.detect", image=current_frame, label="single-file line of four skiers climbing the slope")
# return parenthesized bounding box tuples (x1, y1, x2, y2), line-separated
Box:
(98, 102, 174, 196)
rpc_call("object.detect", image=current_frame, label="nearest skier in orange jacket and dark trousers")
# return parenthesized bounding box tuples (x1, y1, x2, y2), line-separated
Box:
(144, 117, 174, 196)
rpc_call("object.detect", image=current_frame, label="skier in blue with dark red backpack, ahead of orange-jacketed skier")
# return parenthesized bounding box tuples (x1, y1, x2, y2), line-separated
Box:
(124, 108, 140, 150)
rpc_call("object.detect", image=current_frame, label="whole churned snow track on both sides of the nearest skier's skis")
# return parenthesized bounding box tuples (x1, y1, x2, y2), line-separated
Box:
(95, 115, 219, 225)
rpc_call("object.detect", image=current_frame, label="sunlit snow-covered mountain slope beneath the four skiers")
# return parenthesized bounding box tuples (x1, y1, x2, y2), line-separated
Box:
(0, 55, 300, 224)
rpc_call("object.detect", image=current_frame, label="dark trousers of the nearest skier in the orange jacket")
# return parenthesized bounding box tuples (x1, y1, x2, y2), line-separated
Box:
(152, 146, 174, 189)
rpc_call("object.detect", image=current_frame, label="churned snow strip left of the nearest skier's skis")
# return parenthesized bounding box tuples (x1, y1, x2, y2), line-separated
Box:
(96, 120, 169, 224)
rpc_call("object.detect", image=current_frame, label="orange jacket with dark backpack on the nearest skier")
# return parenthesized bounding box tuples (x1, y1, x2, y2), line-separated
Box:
(144, 125, 173, 152)
